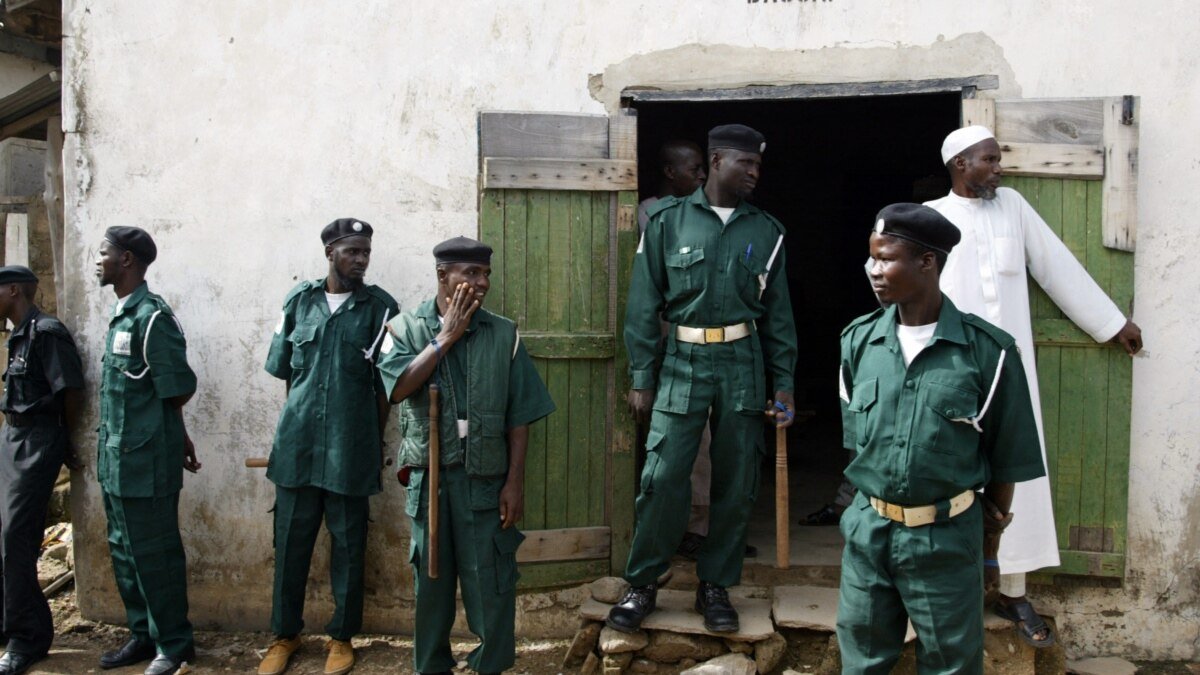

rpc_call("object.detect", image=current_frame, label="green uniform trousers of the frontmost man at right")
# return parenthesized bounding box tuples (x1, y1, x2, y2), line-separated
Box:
(838, 492, 983, 675)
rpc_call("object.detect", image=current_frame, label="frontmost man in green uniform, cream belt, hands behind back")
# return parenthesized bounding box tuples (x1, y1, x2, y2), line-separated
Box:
(838, 204, 1043, 674)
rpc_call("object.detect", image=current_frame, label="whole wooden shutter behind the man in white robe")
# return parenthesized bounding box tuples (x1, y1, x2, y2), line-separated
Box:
(962, 96, 1139, 578)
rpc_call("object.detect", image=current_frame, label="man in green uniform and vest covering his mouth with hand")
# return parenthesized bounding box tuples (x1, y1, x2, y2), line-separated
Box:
(379, 237, 554, 674)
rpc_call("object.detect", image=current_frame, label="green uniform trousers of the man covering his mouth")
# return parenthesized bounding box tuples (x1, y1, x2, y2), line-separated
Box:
(406, 465, 524, 673)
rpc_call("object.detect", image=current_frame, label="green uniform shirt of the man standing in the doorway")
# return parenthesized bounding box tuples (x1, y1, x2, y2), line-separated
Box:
(625, 187, 797, 391)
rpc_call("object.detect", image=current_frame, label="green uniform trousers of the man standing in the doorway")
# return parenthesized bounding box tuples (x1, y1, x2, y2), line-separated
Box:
(625, 338, 767, 587)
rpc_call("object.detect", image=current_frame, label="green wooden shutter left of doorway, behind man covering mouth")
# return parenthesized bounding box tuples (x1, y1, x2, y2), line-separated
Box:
(479, 110, 637, 589)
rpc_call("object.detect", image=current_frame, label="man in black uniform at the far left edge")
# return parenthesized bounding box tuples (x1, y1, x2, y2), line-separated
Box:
(0, 265, 83, 675)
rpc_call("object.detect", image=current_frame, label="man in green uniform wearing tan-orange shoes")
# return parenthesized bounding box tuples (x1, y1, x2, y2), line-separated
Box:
(258, 219, 400, 675)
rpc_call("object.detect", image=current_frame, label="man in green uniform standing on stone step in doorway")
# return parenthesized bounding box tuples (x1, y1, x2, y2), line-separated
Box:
(607, 125, 796, 632)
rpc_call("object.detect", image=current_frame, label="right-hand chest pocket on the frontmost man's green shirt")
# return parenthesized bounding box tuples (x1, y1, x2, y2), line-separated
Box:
(916, 382, 979, 466)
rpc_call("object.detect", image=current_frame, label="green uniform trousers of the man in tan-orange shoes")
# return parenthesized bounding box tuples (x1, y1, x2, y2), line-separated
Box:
(271, 485, 370, 640)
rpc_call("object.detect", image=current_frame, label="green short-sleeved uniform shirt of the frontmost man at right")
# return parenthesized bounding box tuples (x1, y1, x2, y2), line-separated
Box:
(840, 294, 1045, 506)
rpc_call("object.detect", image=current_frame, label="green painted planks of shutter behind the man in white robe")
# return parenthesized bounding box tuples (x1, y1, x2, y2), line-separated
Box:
(1006, 178, 1134, 577)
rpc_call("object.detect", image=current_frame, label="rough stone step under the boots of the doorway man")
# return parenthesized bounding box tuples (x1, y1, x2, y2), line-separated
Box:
(563, 577, 787, 675)
